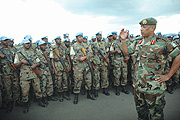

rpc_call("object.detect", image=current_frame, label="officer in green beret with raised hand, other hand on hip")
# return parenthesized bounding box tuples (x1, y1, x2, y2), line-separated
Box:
(120, 18, 180, 120)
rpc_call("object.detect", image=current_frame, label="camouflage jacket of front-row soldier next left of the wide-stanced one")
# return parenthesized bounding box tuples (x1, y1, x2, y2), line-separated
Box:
(50, 44, 69, 71)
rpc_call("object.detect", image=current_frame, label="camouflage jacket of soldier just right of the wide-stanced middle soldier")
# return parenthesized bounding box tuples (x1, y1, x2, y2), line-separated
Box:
(91, 41, 107, 66)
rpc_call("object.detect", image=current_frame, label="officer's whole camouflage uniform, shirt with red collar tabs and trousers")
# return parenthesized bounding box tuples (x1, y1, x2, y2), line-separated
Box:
(128, 35, 180, 120)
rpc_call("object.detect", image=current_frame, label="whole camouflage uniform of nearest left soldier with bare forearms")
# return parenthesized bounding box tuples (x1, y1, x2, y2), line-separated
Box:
(14, 49, 42, 103)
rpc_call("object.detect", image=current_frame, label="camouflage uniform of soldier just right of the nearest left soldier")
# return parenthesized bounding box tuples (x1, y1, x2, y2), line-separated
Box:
(37, 50, 53, 98)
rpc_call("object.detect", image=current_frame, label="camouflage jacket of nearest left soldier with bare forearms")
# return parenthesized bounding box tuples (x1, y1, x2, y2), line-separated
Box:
(14, 48, 40, 80)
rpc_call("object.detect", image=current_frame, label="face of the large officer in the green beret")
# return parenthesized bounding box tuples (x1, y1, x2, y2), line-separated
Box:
(140, 25, 155, 37)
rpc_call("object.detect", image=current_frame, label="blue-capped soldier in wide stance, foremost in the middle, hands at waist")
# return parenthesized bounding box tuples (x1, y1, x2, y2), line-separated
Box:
(71, 33, 95, 104)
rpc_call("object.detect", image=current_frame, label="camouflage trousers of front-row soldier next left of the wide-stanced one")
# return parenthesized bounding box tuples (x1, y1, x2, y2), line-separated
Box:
(55, 71, 68, 92)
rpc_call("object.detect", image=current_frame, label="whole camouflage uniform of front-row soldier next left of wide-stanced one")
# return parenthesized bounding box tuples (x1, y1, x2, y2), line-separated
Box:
(50, 44, 69, 93)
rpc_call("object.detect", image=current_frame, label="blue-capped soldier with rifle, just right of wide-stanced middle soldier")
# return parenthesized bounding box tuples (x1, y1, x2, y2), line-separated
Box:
(92, 32, 110, 97)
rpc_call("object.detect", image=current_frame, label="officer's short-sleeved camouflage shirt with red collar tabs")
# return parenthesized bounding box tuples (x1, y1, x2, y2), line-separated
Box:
(128, 36, 180, 94)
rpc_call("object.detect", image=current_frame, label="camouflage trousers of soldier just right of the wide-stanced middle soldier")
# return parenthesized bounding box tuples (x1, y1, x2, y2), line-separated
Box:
(93, 65, 109, 90)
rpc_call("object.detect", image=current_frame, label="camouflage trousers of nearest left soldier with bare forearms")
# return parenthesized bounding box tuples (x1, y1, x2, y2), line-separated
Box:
(20, 77, 42, 102)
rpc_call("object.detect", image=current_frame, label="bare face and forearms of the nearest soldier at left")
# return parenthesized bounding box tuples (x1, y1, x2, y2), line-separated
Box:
(15, 43, 40, 69)
